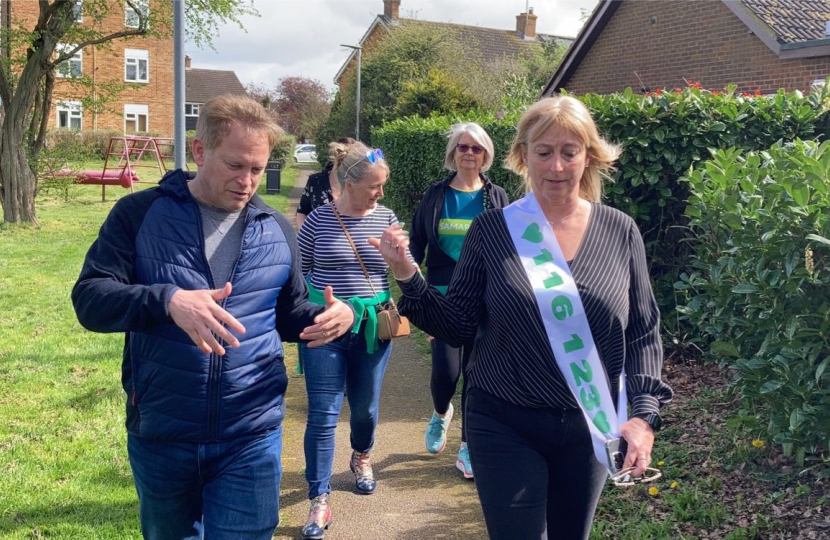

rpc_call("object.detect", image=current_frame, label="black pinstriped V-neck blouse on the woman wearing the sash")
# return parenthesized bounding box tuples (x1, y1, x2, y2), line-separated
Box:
(398, 204, 672, 415)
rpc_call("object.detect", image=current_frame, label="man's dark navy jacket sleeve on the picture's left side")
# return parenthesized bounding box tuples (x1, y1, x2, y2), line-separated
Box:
(72, 193, 178, 332)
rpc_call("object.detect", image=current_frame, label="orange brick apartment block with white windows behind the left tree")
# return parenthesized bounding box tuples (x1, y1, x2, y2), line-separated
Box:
(2, 0, 173, 135)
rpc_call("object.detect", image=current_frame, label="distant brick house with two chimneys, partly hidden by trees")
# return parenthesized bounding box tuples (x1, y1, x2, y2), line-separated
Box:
(334, 0, 573, 95)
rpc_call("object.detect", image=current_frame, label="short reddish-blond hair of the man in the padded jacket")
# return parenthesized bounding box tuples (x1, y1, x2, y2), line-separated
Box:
(196, 94, 285, 150)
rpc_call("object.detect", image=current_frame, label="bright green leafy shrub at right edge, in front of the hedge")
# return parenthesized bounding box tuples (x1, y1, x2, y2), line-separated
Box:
(675, 140, 830, 464)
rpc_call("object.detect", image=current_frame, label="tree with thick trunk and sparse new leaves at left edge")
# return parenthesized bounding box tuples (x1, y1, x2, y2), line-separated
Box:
(0, 0, 257, 223)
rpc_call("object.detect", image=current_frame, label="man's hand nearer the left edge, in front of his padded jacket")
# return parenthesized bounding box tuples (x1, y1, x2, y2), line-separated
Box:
(168, 283, 245, 356)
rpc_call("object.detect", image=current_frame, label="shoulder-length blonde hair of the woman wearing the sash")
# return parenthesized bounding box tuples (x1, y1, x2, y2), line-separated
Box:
(505, 96, 620, 203)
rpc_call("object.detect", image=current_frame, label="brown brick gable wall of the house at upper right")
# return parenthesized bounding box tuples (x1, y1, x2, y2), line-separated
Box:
(564, 1, 830, 94)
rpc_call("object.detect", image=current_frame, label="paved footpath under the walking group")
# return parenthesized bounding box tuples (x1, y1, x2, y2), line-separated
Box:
(274, 169, 487, 540)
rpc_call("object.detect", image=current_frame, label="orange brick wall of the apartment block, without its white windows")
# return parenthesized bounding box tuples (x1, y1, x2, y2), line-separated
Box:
(10, 0, 174, 136)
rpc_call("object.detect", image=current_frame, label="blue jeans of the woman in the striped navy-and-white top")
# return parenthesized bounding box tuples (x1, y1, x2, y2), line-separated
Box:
(302, 332, 392, 499)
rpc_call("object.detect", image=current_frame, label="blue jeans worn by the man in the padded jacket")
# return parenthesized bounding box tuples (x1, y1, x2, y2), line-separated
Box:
(127, 427, 282, 540)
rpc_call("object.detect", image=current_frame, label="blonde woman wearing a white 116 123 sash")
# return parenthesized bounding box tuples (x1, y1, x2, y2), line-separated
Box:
(370, 97, 672, 540)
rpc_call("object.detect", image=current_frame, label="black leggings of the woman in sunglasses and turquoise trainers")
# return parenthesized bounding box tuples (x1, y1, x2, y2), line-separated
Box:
(429, 338, 473, 442)
